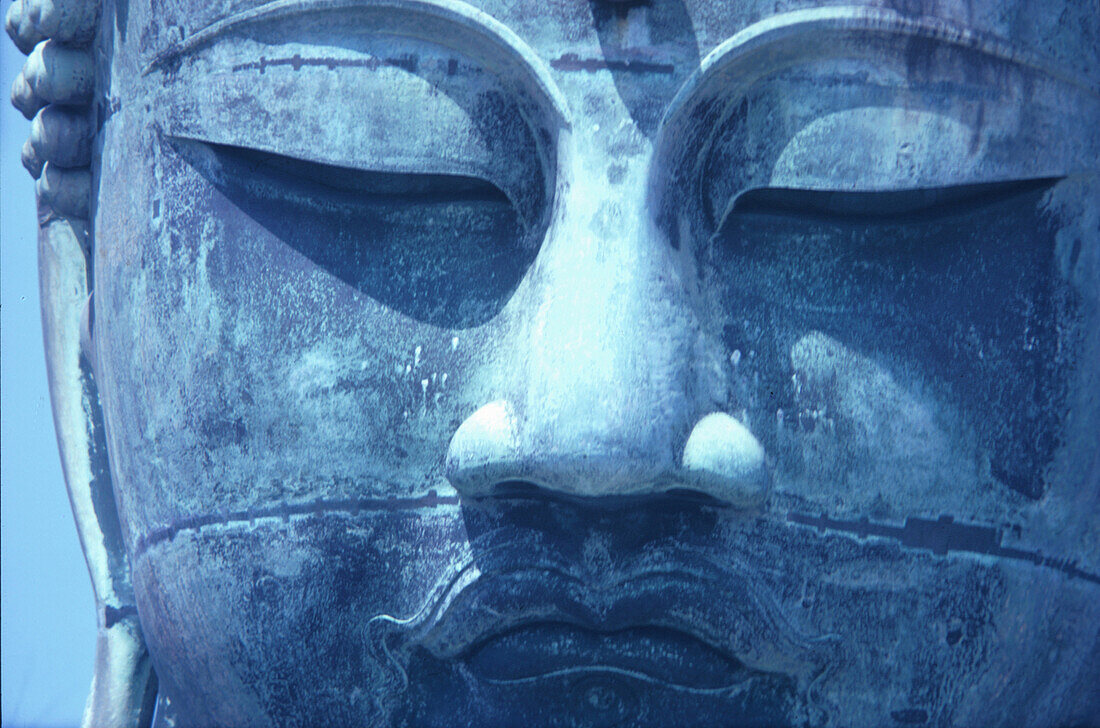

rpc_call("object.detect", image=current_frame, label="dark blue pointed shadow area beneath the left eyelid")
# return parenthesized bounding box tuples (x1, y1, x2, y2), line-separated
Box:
(171, 139, 537, 329)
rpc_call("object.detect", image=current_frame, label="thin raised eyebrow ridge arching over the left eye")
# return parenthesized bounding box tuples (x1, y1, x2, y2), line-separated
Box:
(143, 0, 571, 128)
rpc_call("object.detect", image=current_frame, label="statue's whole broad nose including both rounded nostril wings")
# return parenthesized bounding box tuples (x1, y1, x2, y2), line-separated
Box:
(447, 152, 768, 506)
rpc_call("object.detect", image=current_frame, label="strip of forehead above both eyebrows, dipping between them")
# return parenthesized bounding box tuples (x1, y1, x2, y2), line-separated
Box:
(112, 0, 1100, 100)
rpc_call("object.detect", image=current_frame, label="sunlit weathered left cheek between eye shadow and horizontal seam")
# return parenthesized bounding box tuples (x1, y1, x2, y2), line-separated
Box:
(97, 135, 486, 523)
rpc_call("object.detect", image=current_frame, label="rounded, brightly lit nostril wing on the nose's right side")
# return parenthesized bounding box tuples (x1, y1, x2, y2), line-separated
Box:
(682, 412, 770, 508)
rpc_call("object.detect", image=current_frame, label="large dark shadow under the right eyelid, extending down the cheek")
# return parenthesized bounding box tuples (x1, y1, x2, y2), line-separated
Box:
(706, 178, 1080, 498)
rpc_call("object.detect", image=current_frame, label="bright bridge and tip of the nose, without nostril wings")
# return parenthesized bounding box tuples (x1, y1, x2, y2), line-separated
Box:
(497, 129, 697, 495)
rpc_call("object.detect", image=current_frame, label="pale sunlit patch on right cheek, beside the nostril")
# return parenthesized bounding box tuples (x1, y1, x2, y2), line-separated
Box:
(777, 331, 988, 510)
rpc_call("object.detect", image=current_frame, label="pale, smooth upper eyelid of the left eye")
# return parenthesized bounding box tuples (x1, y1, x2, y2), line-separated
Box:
(156, 64, 541, 220)
